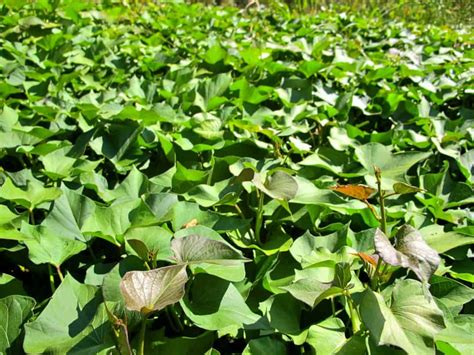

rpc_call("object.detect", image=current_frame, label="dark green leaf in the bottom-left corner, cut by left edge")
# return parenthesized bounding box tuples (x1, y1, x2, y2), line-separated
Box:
(0, 295, 36, 354)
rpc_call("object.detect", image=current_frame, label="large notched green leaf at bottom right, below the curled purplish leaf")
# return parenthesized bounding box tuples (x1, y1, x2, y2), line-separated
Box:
(360, 280, 445, 354)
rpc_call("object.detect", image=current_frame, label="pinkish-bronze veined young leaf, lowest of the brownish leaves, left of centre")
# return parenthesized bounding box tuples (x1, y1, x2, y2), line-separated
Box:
(120, 265, 188, 314)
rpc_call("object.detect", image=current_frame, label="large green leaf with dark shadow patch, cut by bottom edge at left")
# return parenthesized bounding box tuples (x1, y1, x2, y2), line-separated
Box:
(23, 275, 113, 353)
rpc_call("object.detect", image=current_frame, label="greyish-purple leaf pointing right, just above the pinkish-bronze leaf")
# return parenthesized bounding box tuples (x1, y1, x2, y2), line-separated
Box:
(171, 234, 249, 265)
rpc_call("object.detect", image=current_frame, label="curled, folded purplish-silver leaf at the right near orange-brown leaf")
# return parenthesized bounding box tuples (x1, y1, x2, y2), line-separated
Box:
(375, 224, 441, 282)
